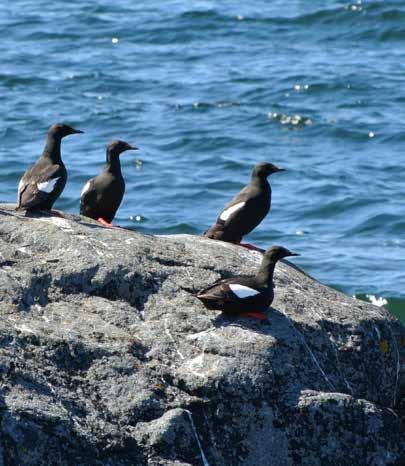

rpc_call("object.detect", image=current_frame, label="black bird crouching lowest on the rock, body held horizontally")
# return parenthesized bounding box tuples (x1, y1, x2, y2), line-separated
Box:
(197, 246, 299, 320)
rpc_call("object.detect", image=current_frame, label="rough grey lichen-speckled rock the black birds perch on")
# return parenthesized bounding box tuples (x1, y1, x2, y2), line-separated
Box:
(0, 206, 405, 466)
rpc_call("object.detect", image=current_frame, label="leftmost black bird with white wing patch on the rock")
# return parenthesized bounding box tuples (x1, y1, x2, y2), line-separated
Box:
(17, 123, 83, 210)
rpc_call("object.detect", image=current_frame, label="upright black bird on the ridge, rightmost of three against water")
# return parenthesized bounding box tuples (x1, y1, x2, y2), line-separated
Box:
(204, 162, 285, 249)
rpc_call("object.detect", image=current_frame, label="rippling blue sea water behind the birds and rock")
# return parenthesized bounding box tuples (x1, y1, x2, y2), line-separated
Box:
(0, 0, 405, 319)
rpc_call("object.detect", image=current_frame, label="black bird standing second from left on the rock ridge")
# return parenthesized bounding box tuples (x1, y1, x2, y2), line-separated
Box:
(80, 141, 138, 227)
